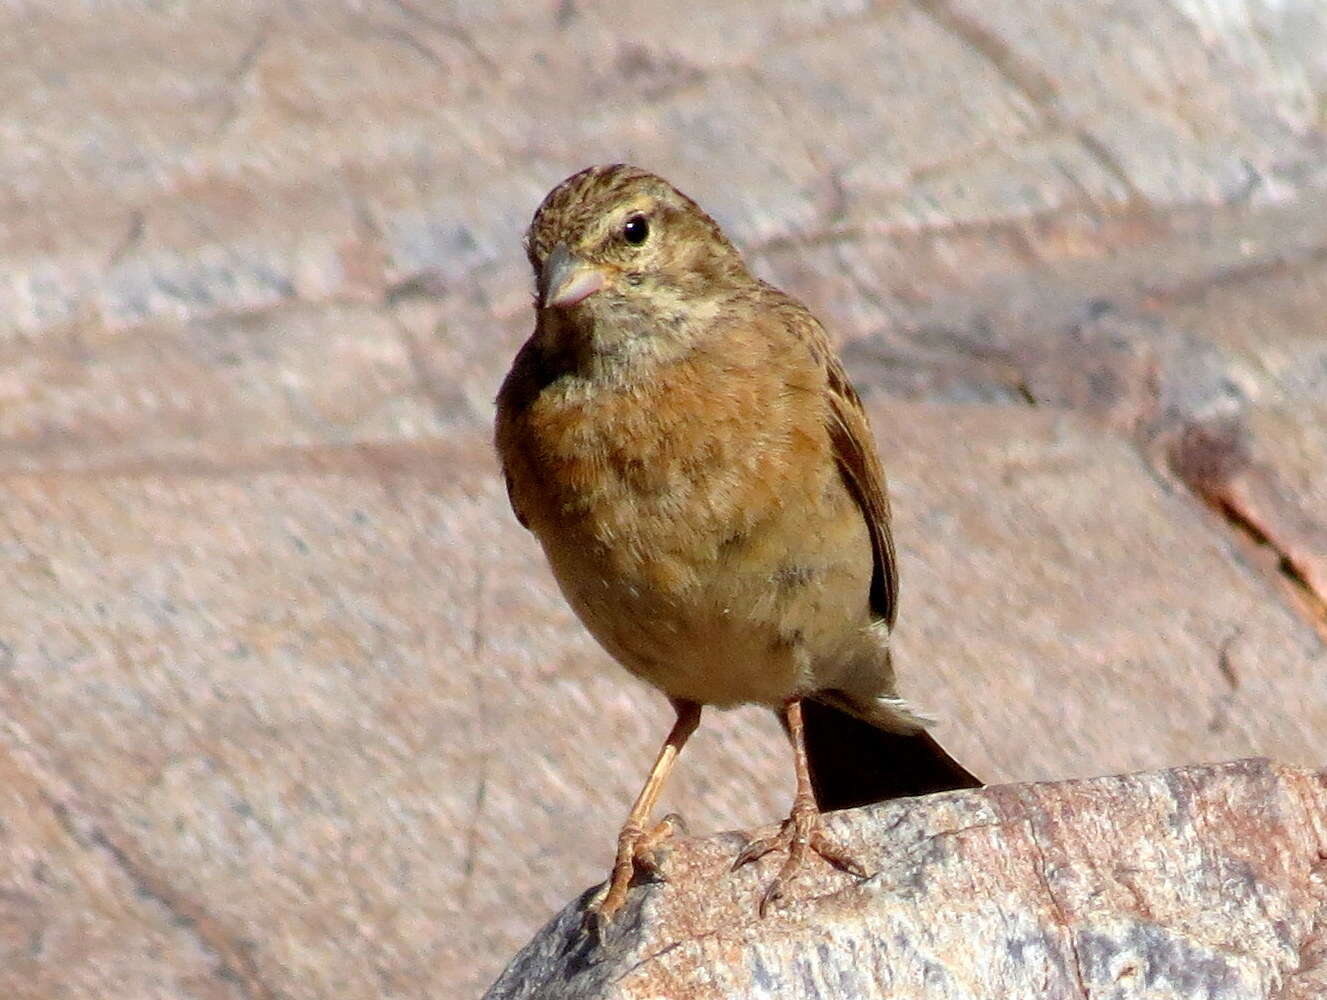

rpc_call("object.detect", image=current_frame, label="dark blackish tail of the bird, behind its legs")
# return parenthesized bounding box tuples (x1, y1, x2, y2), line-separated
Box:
(802, 698, 982, 810)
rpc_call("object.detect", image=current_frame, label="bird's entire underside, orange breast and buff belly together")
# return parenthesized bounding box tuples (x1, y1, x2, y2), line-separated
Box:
(503, 342, 871, 704)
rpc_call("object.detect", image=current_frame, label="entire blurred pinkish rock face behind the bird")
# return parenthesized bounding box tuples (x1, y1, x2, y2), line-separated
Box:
(0, 0, 1327, 1000)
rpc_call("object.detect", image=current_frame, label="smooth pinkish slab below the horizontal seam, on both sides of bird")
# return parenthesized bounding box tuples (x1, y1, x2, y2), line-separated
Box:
(10, 405, 1327, 996)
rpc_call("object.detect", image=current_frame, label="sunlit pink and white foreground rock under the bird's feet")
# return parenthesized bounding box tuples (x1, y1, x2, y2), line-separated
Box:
(486, 760, 1327, 1000)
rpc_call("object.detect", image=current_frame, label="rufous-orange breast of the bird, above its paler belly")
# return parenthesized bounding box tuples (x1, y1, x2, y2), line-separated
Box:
(508, 347, 832, 583)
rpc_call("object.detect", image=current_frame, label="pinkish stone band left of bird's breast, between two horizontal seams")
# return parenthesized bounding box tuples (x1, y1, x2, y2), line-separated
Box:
(0, 304, 445, 469)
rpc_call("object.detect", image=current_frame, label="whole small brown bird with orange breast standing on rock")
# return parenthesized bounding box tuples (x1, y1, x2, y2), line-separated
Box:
(496, 164, 981, 920)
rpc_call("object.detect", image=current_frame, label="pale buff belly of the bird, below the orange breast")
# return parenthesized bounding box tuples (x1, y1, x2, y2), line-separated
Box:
(544, 496, 871, 706)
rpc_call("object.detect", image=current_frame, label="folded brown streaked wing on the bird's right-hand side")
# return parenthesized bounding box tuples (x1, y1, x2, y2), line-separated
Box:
(824, 349, 898, 627)
